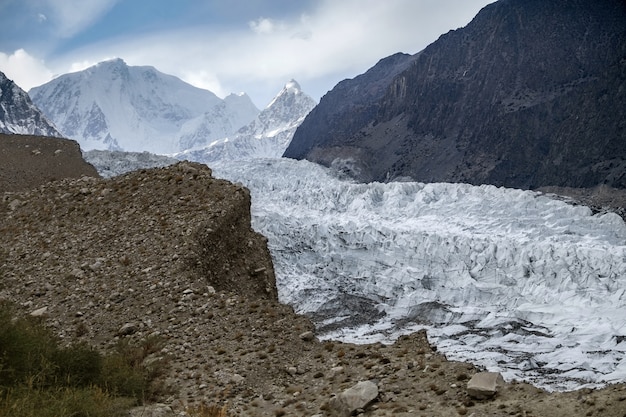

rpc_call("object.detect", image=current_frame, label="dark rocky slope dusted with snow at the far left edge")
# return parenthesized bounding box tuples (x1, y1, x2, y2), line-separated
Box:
(0, 72, 62, 137)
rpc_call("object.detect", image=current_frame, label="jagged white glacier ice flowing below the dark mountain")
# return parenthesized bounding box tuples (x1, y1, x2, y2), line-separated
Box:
(211, 159, 626, 390)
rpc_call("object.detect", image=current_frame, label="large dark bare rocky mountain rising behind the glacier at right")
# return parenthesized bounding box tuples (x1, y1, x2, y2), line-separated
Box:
(284, 0, 626, 188)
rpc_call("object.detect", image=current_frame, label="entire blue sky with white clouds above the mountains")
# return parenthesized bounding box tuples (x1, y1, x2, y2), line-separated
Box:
(0, 0, 493, 108)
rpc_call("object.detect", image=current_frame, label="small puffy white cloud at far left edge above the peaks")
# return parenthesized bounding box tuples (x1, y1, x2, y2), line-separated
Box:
(0, 49, 53, 91)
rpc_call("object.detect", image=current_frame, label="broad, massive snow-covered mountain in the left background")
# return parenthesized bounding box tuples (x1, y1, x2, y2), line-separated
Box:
(29, 59, 259, 154)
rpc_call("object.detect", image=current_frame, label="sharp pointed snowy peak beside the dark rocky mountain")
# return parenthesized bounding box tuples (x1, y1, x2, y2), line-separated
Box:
(175, 80, 316, 164)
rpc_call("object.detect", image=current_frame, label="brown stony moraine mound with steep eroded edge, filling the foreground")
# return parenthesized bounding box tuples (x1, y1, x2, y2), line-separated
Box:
(0, 162, 626, 417)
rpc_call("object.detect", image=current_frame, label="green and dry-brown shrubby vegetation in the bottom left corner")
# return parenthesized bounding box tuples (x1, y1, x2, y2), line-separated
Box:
(0, 303, 164, 417)
